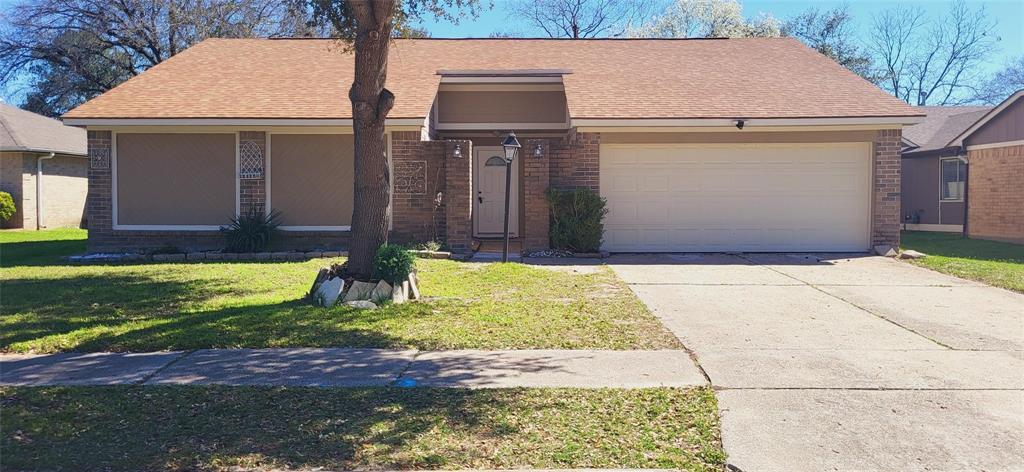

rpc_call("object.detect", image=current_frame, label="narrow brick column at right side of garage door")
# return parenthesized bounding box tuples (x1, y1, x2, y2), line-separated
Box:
(871, 129, 902, 248)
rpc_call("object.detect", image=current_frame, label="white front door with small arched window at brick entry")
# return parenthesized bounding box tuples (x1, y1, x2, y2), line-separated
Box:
(473, 146, 519, 238)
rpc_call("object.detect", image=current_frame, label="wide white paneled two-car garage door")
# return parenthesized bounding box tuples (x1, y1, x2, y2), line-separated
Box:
(600, 143, 871, 252)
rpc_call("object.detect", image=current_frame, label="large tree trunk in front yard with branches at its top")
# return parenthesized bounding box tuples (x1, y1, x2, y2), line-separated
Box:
(310, 0, 479, 280)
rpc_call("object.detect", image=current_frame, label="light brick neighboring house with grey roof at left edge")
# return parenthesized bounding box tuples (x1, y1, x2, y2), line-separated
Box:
(0, 103, 89, 229)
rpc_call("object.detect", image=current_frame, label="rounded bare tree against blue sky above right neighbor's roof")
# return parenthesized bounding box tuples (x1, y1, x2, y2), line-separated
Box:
(868, 1, 998, 105)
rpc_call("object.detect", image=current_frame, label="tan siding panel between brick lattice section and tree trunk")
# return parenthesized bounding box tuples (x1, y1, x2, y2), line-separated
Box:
(269, 134, 354, 226)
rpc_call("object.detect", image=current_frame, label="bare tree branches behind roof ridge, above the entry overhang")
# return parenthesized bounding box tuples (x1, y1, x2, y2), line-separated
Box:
(508, 0, 651, 39)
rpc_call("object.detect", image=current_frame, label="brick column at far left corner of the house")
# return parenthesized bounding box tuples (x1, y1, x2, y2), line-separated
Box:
(85, 131, 115, 252)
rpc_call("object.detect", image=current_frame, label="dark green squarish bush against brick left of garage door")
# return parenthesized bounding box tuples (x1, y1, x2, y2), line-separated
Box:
(546, 188, 608, 252)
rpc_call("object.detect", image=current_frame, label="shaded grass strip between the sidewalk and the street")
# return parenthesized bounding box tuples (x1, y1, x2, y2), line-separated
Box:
(0, 386, 725, 471)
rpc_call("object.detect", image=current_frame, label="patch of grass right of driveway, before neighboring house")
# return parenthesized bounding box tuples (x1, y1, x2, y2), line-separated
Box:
(900, 231, 1024, 293)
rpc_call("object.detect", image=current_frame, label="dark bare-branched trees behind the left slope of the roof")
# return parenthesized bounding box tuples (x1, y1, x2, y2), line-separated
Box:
(0, 0, 317, 116)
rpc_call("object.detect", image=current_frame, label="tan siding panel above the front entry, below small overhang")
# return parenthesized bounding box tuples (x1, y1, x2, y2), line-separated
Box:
(437, 91, 566, 123)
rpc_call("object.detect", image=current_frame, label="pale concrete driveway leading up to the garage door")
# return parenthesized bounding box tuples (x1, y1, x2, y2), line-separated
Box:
(609, 254, 1024, 472)
